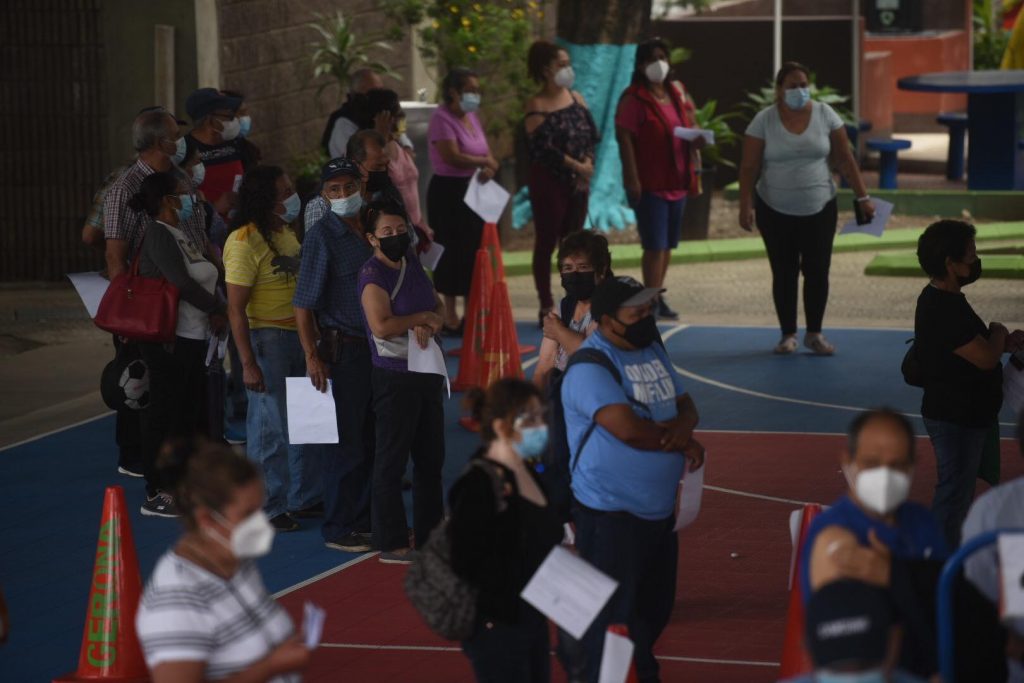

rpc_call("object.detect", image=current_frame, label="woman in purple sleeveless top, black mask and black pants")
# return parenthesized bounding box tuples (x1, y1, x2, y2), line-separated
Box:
(357, 202, 444, 564)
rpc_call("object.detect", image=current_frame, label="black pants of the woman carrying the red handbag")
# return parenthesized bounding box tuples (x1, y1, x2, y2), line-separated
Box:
(139, 337, 207, 498)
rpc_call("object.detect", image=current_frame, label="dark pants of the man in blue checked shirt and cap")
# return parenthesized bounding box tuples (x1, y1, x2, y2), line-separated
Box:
(319, 340, 376, 541)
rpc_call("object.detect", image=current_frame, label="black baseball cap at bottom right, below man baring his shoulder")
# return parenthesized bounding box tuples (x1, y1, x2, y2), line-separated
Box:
(806, 580, 894, 671)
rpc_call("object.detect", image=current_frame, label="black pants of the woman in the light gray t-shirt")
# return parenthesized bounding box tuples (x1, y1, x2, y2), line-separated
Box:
(755, 197, 838, 335)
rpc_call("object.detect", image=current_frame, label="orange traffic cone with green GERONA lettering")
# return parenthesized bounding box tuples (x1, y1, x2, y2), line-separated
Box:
(54, 486, 150, 683)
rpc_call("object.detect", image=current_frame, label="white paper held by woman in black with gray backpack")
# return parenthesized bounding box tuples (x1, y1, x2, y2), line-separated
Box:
(519, 546, 618, 640)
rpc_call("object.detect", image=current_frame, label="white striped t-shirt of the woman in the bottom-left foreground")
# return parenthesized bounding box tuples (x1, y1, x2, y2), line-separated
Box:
(135, 550, 302, 683)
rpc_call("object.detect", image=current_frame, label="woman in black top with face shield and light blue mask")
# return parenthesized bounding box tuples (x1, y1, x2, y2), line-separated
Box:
(449, 379, 562, 683)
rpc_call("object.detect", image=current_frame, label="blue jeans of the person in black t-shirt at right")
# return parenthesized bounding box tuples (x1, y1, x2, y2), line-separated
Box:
(925, 418, 988, 551)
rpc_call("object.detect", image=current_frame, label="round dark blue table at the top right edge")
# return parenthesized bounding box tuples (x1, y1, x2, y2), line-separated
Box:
(898, 71, 1024, 189)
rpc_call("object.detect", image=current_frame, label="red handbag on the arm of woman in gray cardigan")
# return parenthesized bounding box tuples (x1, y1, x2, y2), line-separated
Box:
(93, 234, 178, 342)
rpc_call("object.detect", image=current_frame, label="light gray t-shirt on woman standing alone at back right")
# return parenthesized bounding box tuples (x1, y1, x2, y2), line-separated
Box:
(746, 101, 843, 216)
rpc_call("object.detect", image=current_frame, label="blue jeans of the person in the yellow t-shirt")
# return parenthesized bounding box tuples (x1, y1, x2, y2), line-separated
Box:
(246, 328, 324, 519)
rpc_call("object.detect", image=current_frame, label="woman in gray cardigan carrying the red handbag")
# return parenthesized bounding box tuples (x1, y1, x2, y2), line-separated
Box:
(129, 172, 227, 517)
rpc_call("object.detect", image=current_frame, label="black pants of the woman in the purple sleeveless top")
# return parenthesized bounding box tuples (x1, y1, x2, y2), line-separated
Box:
(371, 367, 444, 551)
